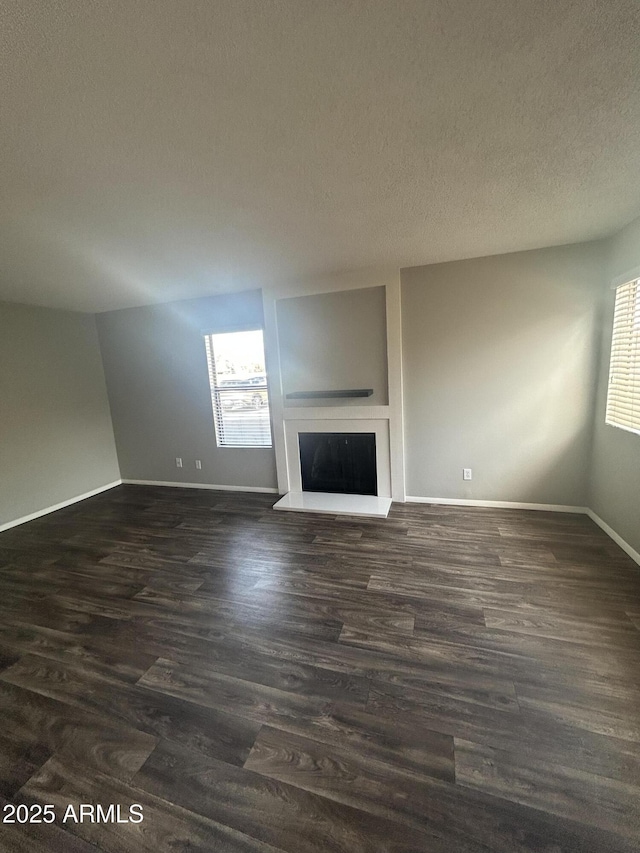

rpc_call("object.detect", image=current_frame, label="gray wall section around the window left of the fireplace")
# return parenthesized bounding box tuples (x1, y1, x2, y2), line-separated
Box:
(97, 291, 276, 488)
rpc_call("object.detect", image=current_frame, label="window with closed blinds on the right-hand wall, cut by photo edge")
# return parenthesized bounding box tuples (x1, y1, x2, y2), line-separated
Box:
(607, 279, 640, 433)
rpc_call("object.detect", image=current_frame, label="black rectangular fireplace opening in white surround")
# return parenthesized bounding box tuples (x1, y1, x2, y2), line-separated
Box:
(298, 432, 378, 495)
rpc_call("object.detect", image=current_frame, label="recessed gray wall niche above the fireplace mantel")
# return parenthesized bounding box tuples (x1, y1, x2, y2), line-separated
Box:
(277, 287, 389, 406)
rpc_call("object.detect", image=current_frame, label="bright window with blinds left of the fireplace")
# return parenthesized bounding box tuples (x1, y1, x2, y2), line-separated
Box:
(205, 329, 271, 447)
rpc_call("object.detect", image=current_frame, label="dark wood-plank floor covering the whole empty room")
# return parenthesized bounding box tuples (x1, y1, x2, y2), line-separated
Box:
(0, 486, 640, 853)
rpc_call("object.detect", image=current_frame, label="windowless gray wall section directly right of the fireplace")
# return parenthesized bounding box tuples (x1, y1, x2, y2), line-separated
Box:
(402, 243, 604, 506)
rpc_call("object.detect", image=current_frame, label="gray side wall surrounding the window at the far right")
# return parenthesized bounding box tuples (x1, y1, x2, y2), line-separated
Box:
(589, 219, 640, 552)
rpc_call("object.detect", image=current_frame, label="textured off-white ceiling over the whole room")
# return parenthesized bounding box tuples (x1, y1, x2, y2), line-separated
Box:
(0, 0, 640, 311)
